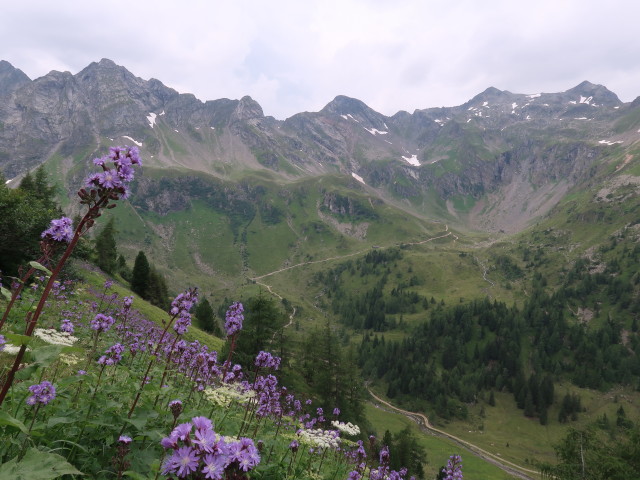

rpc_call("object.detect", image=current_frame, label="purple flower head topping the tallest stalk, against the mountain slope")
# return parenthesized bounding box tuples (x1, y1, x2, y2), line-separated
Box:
(80, 146, 142, 200)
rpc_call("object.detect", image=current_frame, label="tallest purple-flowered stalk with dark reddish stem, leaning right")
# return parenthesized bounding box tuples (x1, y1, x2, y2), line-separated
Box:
(0, 147, 142, 405)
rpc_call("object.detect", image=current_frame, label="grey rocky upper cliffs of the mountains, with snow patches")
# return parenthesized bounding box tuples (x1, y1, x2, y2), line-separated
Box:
(0, 59, 640, 234)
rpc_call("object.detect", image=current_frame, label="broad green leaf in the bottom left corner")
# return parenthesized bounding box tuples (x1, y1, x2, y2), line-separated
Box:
(0, 448, 84, 480)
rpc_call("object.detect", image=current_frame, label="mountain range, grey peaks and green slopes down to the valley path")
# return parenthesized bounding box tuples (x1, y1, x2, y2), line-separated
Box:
(0, 59, 640, 292)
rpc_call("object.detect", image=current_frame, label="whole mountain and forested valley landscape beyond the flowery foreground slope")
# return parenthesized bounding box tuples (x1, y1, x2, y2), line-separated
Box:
(0, 59, 640, 475)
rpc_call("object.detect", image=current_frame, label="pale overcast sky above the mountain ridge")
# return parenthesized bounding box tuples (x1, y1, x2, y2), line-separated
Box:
(5, 0, 640, 119)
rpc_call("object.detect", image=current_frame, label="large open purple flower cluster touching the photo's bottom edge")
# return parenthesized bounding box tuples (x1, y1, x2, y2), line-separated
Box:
(160, 417, 260, 480)
